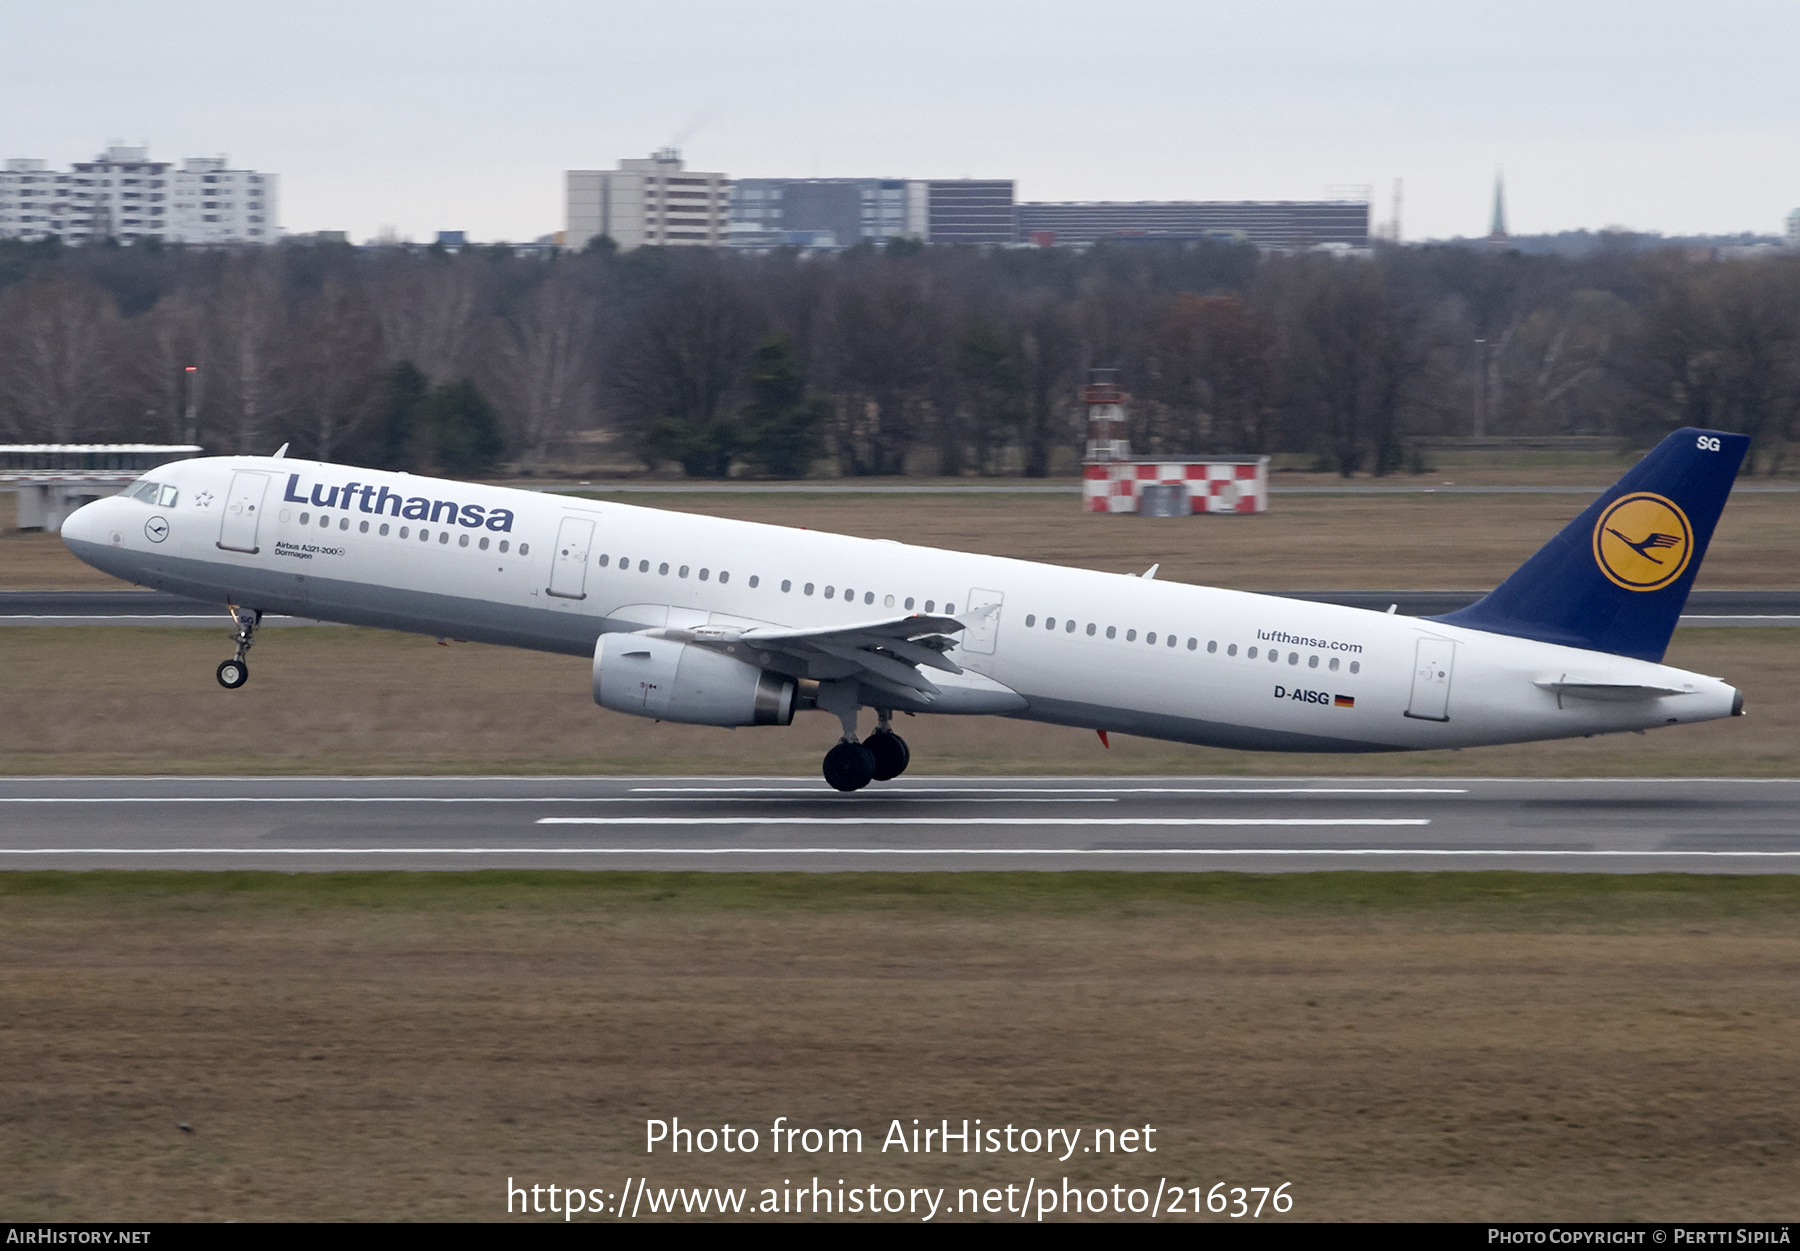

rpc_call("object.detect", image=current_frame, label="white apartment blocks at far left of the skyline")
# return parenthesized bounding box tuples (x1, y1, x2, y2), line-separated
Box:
(0, 146, 279, 243)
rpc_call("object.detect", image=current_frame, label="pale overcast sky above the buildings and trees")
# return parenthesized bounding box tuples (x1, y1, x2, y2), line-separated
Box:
(0, 0, 1800, 239)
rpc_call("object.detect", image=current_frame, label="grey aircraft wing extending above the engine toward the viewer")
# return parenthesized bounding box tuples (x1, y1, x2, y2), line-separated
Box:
(646, 612, 967, 704)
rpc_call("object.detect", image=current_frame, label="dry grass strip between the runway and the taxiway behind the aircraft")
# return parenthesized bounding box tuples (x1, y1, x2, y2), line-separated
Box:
(0, 626, 1800, 776)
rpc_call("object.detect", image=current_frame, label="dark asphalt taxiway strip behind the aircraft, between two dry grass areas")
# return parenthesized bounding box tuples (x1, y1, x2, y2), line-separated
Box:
(0, 590, 1800, 626)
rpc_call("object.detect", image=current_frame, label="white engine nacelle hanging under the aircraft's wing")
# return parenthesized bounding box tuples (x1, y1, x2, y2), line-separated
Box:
(594, 634, 796, 725)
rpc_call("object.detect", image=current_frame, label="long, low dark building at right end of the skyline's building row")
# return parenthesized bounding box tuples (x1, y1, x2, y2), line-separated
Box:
(1017, 200, 1368, 248)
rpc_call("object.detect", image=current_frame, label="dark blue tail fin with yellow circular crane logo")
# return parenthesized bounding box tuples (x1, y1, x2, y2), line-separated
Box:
(1433, 427, 1750, 661)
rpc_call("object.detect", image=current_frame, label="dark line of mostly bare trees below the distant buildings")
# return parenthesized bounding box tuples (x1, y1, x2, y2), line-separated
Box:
(0, 232, 1800, 477)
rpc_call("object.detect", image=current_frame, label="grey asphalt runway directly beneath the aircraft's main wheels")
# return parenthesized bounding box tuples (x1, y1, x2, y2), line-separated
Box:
(0, 778, 1800, 873)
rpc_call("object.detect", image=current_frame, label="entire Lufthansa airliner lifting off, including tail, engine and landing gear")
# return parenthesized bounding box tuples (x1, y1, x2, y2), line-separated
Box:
(63, 428, 1750, 790)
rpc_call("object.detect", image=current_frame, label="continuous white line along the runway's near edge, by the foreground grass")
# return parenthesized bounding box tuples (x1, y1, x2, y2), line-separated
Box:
(0, 848, 1800, 860)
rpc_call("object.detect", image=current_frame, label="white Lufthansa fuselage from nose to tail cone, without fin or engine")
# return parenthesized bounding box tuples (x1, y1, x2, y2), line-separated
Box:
(63, 457, 1737, 751)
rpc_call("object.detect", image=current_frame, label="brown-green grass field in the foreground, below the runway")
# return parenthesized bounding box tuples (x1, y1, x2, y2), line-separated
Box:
(0, 873, 1800, 1220)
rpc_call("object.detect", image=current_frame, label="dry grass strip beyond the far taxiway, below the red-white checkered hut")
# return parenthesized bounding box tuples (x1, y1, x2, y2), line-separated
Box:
(0, 495, 1800, 590)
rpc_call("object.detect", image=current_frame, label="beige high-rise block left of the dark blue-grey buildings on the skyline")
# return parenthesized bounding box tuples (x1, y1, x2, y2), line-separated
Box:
(563, 148, 729, 252)
